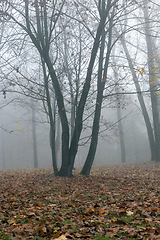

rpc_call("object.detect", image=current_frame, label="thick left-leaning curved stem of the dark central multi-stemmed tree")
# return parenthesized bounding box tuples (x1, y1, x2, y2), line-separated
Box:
(24, 0, 69, 176)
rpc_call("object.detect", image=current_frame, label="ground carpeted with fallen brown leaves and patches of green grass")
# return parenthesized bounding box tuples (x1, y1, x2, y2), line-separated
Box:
(0, 163, 160, 240)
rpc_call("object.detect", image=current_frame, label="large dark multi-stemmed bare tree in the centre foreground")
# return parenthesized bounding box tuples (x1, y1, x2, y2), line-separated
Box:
(0, 0, 155, 176)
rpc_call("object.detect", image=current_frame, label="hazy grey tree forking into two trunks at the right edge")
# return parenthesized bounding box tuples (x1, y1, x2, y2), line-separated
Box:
(110, 1, 159, 161)
